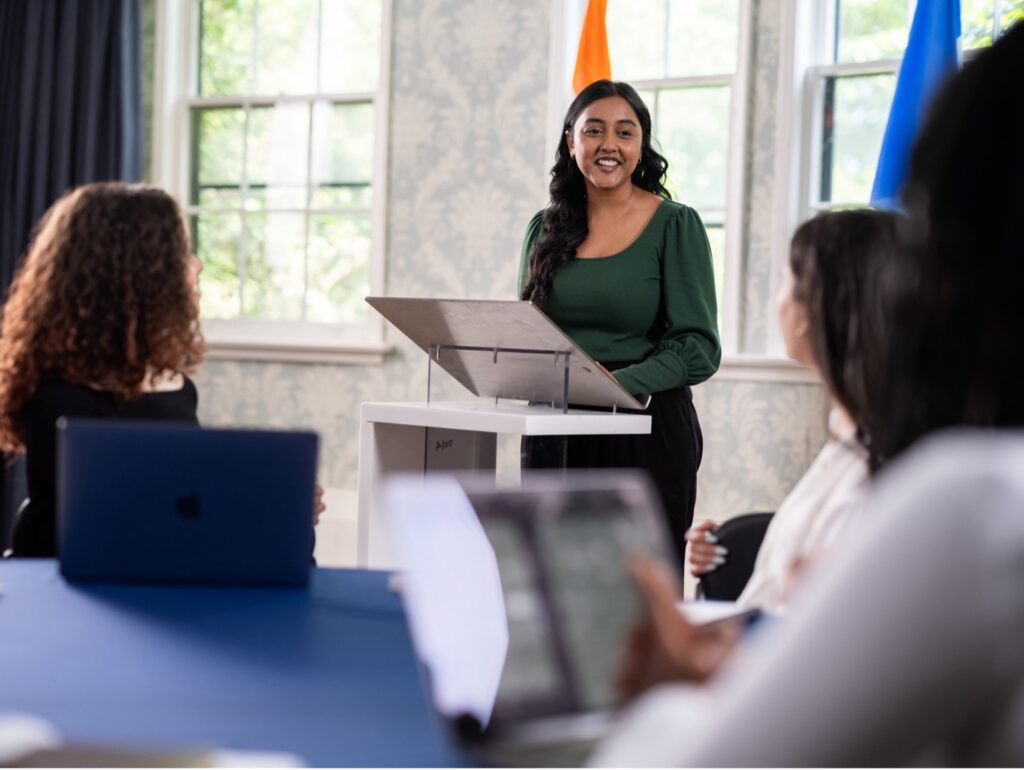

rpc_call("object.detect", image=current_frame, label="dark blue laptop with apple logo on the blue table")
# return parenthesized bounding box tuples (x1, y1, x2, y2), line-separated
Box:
(57, 418, 318, 586)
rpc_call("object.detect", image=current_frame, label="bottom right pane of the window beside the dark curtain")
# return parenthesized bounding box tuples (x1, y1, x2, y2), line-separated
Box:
(306, 214, 370, 323)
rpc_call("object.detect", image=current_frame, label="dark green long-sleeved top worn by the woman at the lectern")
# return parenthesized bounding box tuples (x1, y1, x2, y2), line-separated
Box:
(519, 201, 722, 395)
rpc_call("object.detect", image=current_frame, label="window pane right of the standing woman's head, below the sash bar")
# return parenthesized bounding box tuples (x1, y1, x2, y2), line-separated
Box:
(654, 86, 729, 209)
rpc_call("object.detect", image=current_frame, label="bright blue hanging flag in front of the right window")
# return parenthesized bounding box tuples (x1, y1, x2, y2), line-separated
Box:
(871, 0, 961, 209)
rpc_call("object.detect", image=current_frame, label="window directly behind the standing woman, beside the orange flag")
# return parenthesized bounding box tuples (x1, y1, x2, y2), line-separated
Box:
(558, 0, 751, 352)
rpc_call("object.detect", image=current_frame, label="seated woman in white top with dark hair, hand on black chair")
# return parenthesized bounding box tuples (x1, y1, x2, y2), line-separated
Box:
(686, 210, 900, 612)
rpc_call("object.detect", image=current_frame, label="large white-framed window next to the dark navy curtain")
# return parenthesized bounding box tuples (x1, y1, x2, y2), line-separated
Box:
(158, 0, 389, 357)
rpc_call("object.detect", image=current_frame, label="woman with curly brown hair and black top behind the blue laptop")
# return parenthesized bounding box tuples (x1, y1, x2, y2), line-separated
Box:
(0, 182, 204, 557)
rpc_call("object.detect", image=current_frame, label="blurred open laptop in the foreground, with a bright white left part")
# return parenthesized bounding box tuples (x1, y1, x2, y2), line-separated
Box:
(382, 471, 671, 766)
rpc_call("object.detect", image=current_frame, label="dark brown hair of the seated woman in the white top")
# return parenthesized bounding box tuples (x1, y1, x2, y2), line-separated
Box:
(790, 209, 905, 448)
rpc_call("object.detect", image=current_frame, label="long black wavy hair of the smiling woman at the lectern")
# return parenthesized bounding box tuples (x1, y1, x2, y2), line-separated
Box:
(522, 80, 671, 306)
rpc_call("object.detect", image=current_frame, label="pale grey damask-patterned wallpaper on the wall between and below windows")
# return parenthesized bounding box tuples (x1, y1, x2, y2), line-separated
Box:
(197, 0, 824, 517)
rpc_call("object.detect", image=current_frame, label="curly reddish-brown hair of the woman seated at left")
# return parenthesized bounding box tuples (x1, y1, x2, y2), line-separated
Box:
(0, 182, 205, 451)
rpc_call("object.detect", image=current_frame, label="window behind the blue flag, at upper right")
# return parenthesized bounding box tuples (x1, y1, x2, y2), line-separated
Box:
(801, 0, 1024, 211)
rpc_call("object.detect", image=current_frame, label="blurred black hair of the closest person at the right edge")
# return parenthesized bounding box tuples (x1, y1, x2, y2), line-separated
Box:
(856, 24, 1024, 466)
